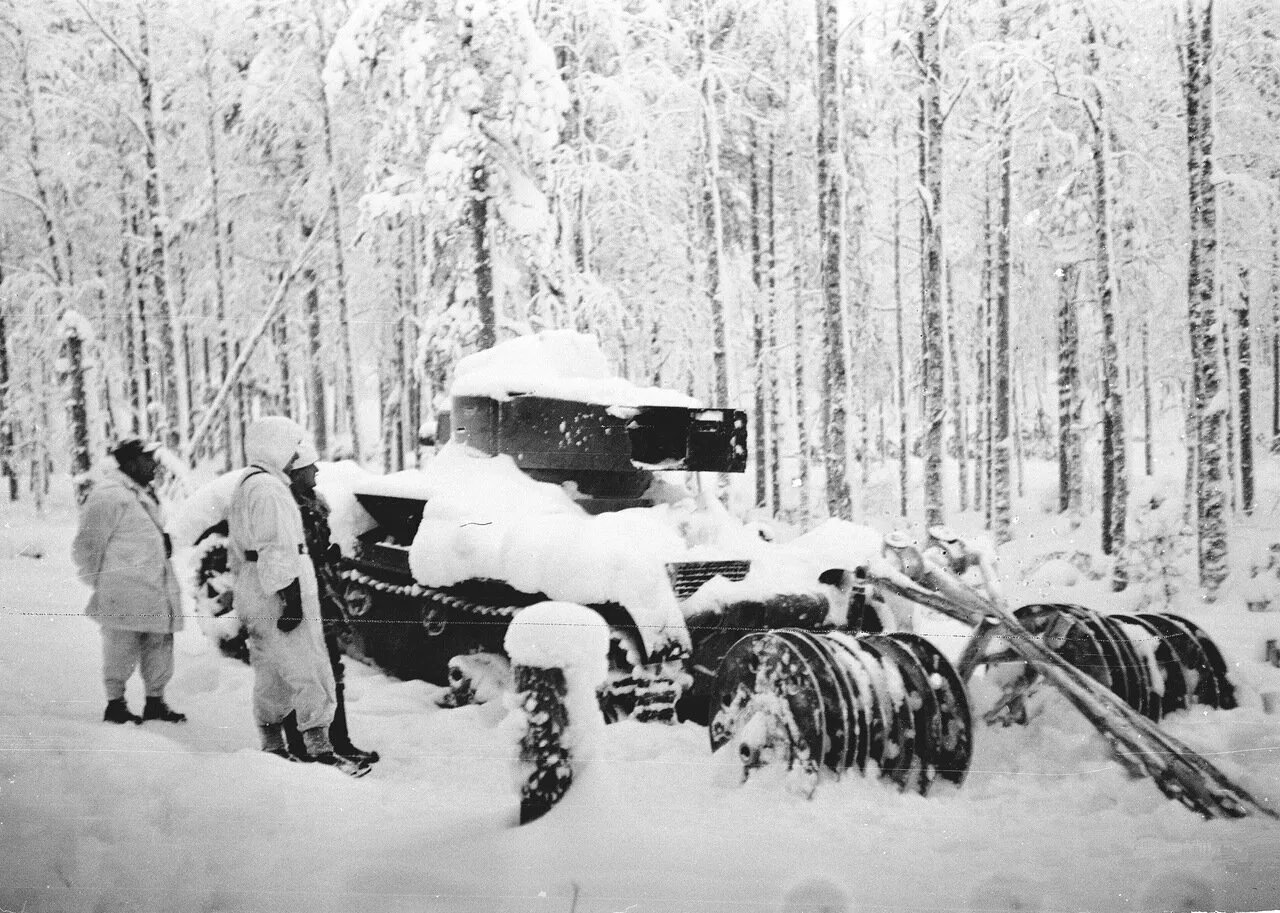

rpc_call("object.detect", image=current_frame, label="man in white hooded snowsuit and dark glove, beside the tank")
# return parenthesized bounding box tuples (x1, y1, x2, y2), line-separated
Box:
(227, 415, 369, 777)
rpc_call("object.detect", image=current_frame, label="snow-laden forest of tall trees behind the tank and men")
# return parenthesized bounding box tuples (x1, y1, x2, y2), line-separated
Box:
(0, 0, 1280, 597)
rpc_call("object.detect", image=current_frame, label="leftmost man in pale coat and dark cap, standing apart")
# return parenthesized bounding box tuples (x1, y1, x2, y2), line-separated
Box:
(72, 438, 187, 723)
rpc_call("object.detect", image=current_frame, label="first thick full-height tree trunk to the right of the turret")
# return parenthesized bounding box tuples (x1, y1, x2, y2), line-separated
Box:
(817, 0, 852, 520)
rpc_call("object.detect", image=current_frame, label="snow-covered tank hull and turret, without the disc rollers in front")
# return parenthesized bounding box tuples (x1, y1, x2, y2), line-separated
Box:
(332, 333, 881, 720)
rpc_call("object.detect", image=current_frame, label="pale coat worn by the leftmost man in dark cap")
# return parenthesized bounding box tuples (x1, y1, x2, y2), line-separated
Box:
(72, 469, 182, 634)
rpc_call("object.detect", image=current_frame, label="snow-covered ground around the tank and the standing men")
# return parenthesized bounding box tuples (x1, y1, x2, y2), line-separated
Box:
(0, 455, 1280, 913)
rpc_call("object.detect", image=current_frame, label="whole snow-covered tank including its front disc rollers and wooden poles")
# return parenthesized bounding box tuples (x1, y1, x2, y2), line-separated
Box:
(175, 332, 1260, 817)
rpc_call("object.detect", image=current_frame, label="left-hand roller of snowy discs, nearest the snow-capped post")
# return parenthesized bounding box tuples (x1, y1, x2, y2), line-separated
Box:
(709, 629, 973, 794)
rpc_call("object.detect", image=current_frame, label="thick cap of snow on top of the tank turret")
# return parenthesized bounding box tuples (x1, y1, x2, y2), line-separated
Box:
(452, 329, 703, 408)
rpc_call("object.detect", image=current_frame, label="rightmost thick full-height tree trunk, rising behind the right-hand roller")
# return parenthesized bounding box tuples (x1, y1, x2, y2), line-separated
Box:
(1185, 0, 1228, 599)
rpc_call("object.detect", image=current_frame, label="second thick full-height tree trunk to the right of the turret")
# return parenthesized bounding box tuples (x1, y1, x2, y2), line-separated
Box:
(920, 0, 946, 526)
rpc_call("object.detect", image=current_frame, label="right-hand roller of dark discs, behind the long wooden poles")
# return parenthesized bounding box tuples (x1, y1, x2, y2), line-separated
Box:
(982, 603, 1235, 722)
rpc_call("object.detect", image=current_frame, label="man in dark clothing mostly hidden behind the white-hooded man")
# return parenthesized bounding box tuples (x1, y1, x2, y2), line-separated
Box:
(284, 451, 379, 764)
